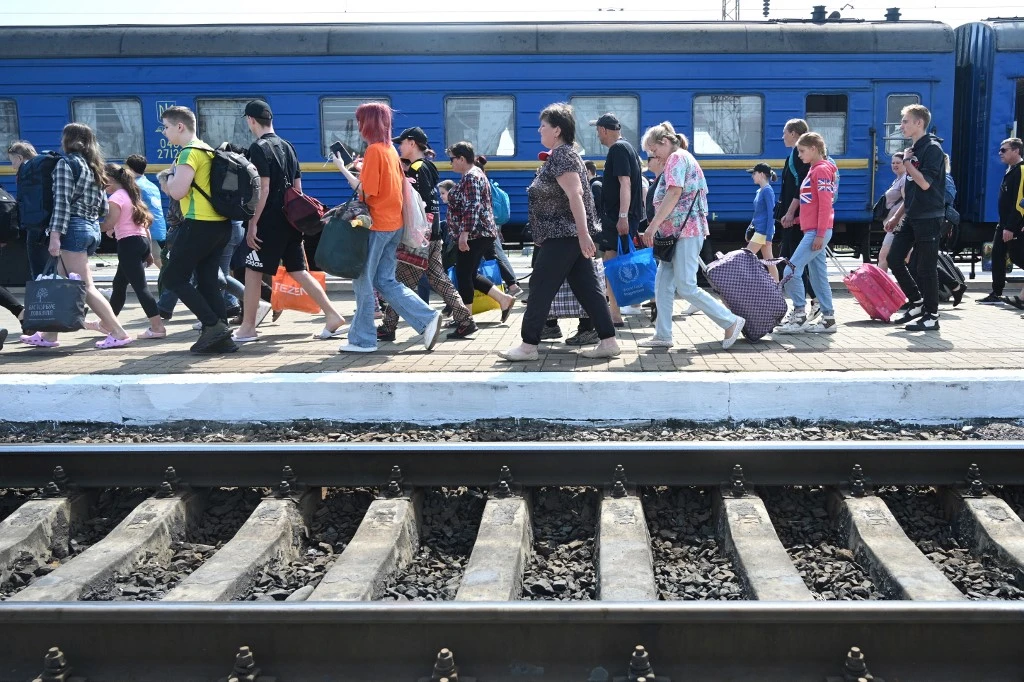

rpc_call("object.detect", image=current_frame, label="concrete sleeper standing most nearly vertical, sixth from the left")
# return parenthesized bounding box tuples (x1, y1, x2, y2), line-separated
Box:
(597, 495, 657, 601)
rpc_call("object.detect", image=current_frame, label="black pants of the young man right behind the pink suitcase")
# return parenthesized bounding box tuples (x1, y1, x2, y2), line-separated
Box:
(889, 218, 942, 315)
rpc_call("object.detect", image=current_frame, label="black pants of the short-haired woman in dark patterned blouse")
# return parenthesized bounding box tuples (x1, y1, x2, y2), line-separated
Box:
(522, 237, 615, 346)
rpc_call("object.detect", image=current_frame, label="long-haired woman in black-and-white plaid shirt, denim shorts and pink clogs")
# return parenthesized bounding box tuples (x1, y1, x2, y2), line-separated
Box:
(20, 123, 132, 348)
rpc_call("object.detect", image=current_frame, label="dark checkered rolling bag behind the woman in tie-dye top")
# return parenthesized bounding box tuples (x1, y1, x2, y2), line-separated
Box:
(700, 249, 788, 341)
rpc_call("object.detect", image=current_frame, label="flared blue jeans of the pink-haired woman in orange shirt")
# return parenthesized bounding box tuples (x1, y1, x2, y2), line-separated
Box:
(348, 229, 438, 348)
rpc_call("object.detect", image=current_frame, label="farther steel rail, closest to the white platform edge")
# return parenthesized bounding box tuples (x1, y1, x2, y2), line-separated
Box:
(0, 440, 1024, 487)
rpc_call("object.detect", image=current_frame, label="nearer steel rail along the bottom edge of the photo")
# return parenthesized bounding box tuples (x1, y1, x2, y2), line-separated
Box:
(0, 602, 1024, 682)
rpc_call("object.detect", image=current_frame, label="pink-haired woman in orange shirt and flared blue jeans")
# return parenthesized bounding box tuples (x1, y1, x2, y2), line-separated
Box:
(333, 101, 441, 353)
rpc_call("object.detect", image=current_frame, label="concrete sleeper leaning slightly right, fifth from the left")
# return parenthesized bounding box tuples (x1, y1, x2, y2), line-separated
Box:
(455, 498, 534, 601)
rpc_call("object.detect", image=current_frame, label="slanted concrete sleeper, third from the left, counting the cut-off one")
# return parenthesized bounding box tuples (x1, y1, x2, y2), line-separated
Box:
(163, 487, 321, 601)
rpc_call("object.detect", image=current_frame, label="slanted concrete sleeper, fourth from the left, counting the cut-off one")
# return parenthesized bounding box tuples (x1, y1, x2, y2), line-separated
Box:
(308, 492, 422, 601)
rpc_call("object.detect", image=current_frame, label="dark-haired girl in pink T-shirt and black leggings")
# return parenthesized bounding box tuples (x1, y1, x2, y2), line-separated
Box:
(86, 164, 167, 339)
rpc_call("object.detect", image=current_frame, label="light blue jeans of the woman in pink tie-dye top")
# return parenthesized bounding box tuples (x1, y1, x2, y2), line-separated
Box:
(654, 237, 736, 341)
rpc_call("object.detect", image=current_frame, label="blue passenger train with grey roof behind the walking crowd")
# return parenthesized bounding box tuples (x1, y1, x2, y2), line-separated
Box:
(0, 17, 1024, 280)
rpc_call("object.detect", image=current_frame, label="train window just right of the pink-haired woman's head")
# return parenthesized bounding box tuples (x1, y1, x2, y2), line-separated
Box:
(444, 97, 515, 157)
